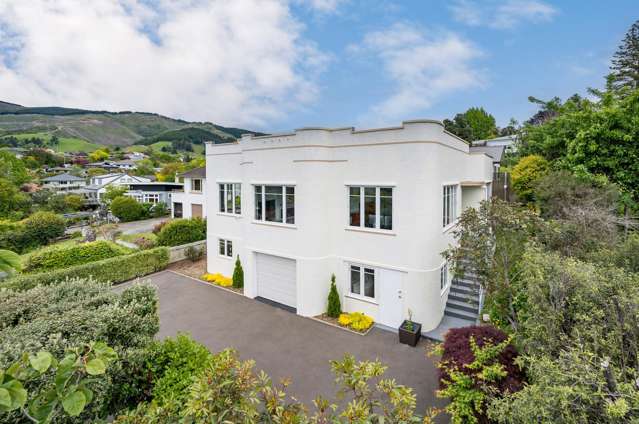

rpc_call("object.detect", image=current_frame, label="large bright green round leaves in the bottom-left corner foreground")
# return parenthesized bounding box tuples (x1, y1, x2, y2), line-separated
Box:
(0, 342, 118, 423)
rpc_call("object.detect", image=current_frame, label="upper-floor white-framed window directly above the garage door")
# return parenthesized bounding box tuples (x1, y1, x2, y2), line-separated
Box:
(254, 185, 295, 224)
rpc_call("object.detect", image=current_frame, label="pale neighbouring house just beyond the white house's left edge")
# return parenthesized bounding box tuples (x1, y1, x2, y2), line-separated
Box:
(171, 168, 206, 218)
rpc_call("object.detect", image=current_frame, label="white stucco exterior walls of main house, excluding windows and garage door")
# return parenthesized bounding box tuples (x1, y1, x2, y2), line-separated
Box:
(206, 121, 492, 331)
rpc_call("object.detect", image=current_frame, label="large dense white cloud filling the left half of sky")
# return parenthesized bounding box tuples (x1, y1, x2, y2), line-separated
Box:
(0, 0, 329, 128)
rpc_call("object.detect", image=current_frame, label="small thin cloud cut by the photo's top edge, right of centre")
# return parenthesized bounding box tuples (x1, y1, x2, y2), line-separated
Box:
(450, 0, 558, 29)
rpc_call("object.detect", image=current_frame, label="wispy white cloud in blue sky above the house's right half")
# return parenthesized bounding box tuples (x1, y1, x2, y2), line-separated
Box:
(350, 24, 485, 123)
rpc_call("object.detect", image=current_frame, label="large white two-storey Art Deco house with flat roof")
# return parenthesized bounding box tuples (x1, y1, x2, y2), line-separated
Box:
(205, 120, 492, 332)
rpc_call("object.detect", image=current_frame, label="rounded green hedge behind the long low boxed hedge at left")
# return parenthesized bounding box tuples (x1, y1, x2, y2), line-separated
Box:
(24, 240, 127, 272)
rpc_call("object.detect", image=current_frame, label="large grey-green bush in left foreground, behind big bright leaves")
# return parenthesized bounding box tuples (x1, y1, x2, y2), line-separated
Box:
(0, 280, 159, 422)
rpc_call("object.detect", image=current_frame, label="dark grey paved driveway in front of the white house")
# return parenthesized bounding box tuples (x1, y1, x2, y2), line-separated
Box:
(118, 271, 445, 422)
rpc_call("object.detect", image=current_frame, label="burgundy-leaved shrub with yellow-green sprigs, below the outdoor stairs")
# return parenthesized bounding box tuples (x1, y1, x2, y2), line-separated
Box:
(437, 326, 524, 423)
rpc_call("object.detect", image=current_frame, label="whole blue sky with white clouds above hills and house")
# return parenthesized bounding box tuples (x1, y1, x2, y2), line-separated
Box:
(0, 0, 639, 132)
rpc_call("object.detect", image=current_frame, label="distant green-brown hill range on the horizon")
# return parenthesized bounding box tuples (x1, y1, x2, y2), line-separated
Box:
(0, 101, 262, 147)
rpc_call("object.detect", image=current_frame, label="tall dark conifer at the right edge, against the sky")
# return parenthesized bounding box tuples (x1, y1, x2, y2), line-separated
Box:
(610, 21, 639, 90)
